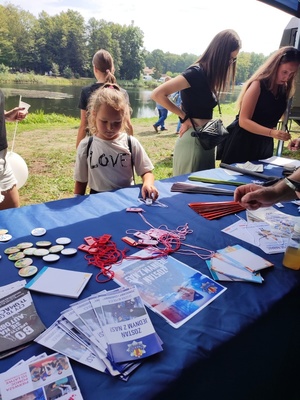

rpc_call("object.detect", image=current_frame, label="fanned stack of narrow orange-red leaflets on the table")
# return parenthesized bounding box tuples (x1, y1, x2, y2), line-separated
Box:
(189, 201, 245, 220)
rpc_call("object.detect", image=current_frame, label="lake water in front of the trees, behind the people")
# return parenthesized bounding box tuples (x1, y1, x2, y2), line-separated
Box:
(1, 84, 240, 118)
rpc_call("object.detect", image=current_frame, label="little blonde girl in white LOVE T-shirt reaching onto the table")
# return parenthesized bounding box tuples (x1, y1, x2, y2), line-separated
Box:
(74, 83, 158, 200)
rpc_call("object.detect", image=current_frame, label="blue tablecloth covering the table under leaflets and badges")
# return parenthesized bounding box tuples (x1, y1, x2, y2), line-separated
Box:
(0, 167, 300, 400)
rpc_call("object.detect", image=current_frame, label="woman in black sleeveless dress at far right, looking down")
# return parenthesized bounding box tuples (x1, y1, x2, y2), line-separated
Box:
(220, 46, 300, 164)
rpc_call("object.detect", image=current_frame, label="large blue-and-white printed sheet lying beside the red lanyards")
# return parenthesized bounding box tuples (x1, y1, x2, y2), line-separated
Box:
(113, 250, 226, 328)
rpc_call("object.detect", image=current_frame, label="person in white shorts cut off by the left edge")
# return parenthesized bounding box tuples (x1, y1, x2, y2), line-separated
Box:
(0, 90, 28, 210)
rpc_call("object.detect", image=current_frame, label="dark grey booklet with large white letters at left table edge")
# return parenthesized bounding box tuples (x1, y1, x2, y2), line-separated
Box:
(0, 284, 46, 358)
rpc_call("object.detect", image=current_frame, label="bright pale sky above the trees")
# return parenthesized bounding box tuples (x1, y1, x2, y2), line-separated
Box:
(0, 0, 293, 56)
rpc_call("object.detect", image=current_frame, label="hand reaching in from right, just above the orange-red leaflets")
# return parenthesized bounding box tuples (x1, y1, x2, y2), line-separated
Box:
(234, 183, 274, 210)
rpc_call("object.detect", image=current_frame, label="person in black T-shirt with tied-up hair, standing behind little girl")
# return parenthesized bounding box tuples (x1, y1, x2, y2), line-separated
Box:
(76, 49, 133, 148)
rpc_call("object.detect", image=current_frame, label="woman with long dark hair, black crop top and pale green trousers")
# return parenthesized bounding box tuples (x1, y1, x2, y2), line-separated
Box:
(151, 29, 241, 175)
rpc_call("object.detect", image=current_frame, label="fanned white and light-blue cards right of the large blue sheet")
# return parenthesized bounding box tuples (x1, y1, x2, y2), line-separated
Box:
(206, 245, 273, 283)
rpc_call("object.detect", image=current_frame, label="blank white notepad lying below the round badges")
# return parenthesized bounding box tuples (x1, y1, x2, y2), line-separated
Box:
(25, 267, 92, 299)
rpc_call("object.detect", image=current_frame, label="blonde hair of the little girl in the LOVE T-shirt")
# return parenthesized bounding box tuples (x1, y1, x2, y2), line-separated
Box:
(88, 83, 130, 134)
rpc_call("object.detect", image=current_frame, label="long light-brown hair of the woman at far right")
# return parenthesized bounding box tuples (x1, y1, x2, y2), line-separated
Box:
(237, 46, 300, 108)
